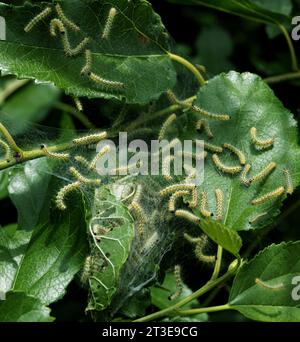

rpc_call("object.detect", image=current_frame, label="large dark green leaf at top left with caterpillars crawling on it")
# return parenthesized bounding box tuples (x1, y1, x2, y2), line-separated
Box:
(0, 0, 176, 103)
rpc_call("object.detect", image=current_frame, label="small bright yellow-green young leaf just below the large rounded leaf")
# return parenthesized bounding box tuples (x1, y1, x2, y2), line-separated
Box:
(200, 220, 242, 255)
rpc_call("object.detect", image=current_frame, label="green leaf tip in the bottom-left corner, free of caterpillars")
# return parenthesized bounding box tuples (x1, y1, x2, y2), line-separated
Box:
(0, 292, 54, 322)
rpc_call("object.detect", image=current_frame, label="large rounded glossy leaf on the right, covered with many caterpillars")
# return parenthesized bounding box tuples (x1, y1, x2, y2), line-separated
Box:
(186, 72, 300, 231)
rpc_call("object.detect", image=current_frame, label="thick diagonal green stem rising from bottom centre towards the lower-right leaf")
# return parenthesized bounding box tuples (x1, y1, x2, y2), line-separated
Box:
(134, 263, 239, 322)
